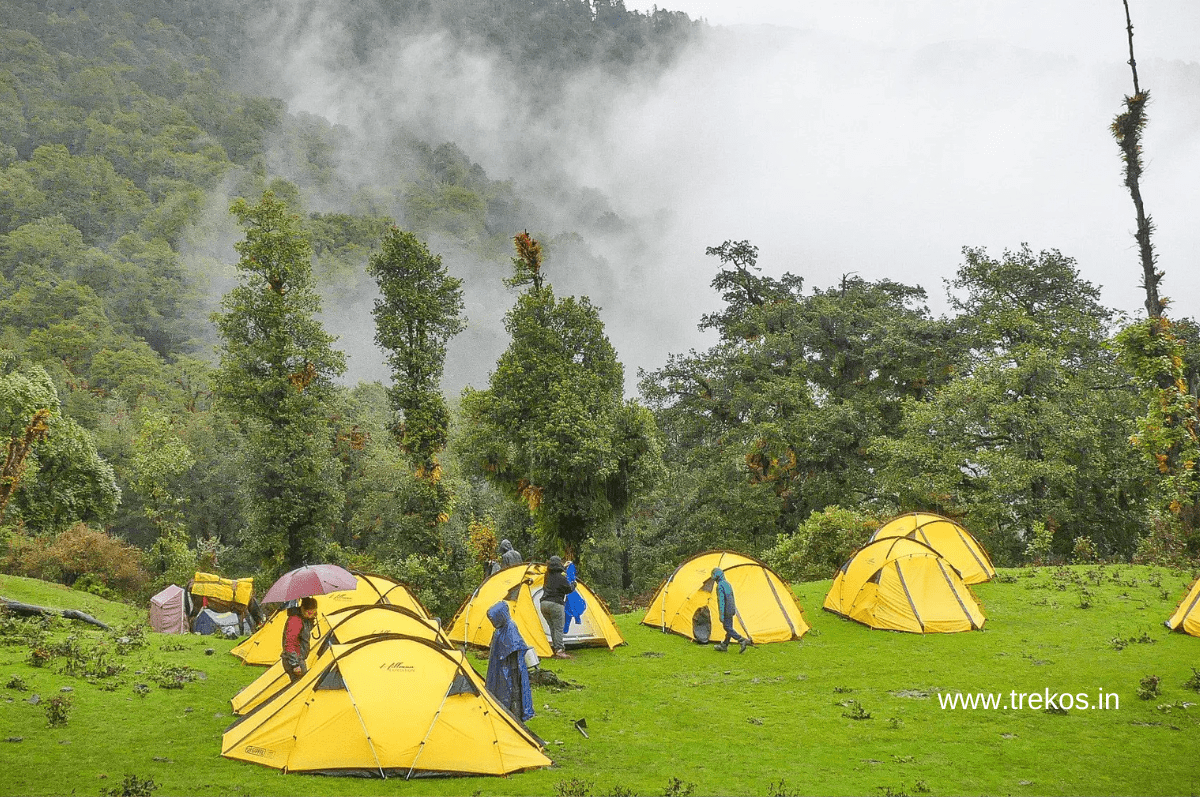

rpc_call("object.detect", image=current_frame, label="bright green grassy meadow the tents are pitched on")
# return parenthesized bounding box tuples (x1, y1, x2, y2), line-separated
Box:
(0, 565, 1200, 795)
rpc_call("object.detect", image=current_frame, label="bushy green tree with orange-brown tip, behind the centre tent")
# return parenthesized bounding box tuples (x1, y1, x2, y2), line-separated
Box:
(463, 233, 659, 558)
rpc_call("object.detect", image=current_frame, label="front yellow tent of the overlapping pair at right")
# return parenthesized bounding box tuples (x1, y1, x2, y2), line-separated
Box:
(824, 537, 986, 634)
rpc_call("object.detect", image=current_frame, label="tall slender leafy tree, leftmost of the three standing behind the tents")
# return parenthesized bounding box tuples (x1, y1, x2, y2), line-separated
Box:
(215, 192, 346, 569)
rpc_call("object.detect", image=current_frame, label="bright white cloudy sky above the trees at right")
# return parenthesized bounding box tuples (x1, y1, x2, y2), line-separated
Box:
(594, 0, 1200, 350)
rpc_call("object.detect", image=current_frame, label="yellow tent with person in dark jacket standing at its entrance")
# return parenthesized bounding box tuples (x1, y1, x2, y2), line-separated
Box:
(446, 563, 625, 659)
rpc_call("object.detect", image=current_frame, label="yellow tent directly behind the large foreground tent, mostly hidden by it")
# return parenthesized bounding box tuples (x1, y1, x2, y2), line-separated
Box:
(229, 604, 452, 715)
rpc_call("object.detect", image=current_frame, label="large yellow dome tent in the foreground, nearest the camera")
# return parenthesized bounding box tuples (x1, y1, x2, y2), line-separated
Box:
(221, 634, 551, 778)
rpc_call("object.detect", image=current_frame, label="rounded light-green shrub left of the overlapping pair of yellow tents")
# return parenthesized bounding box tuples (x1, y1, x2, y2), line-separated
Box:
(763, 505, 880, 581)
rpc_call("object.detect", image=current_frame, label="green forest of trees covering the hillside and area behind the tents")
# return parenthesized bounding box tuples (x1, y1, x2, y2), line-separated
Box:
(0, 0, 1200, 617)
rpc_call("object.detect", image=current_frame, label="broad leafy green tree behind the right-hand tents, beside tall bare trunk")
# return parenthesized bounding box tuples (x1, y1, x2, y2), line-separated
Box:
(878, 247, 1146, 562)
